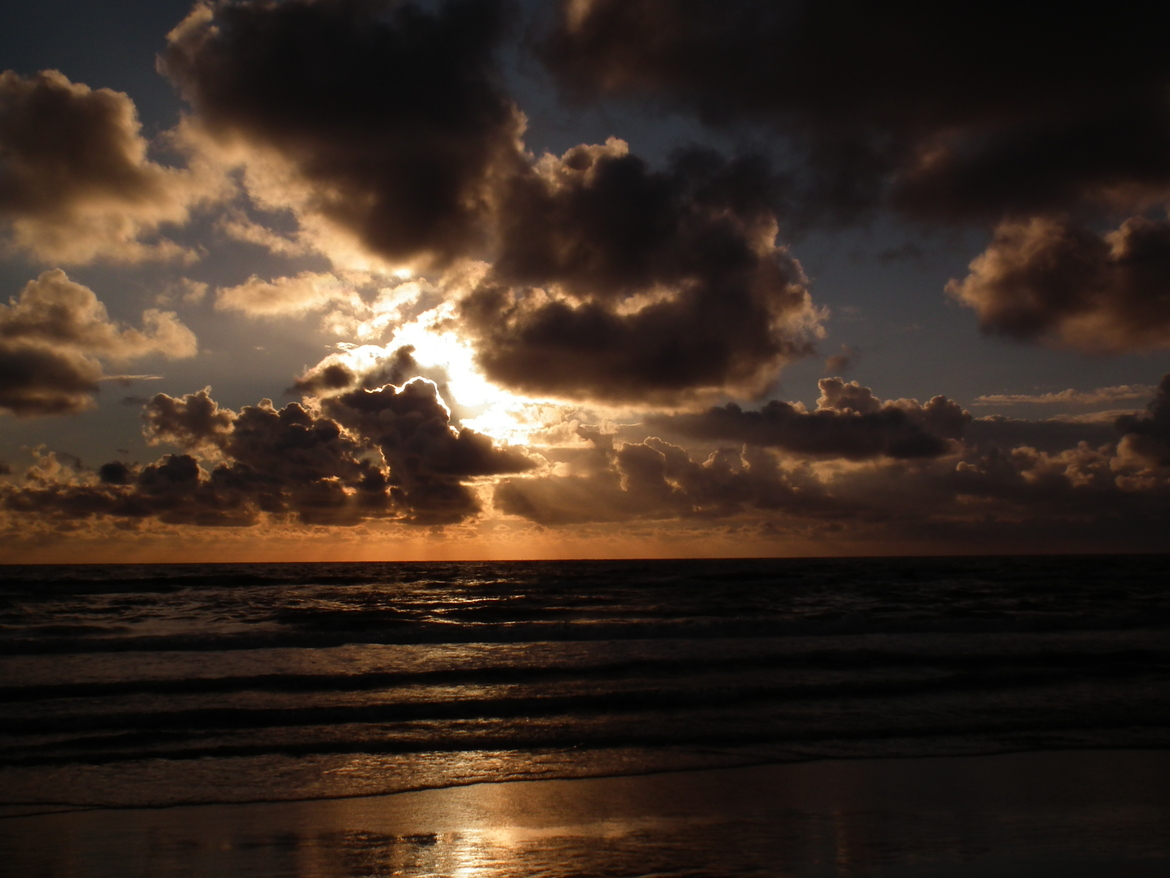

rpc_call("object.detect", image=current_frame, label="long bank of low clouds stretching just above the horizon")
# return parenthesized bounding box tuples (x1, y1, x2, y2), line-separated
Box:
(11, 377, 1170, 549)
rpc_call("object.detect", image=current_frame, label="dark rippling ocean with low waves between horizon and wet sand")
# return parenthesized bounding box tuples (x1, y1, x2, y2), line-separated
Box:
(0, 556, 1170, 874)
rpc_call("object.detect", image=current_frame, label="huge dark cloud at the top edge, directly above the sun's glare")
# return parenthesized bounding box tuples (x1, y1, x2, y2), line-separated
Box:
(161, 0, 523, 270)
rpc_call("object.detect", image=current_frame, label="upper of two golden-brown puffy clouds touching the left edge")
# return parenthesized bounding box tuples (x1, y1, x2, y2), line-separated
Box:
(0, 70, 219, 265)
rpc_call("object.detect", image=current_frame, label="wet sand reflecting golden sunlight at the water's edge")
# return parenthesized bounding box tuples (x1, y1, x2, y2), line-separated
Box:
(0, 750, 1170, 878)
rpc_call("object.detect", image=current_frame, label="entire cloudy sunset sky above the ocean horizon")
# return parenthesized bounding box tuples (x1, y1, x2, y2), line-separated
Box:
(0, 0, 1170, 562)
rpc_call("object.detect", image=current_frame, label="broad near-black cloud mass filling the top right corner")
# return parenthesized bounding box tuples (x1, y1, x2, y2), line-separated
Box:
(541, 0, 1170, 219)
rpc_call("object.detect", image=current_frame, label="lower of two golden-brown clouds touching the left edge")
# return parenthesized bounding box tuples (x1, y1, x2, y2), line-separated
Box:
(0, 269, 197, 417)
